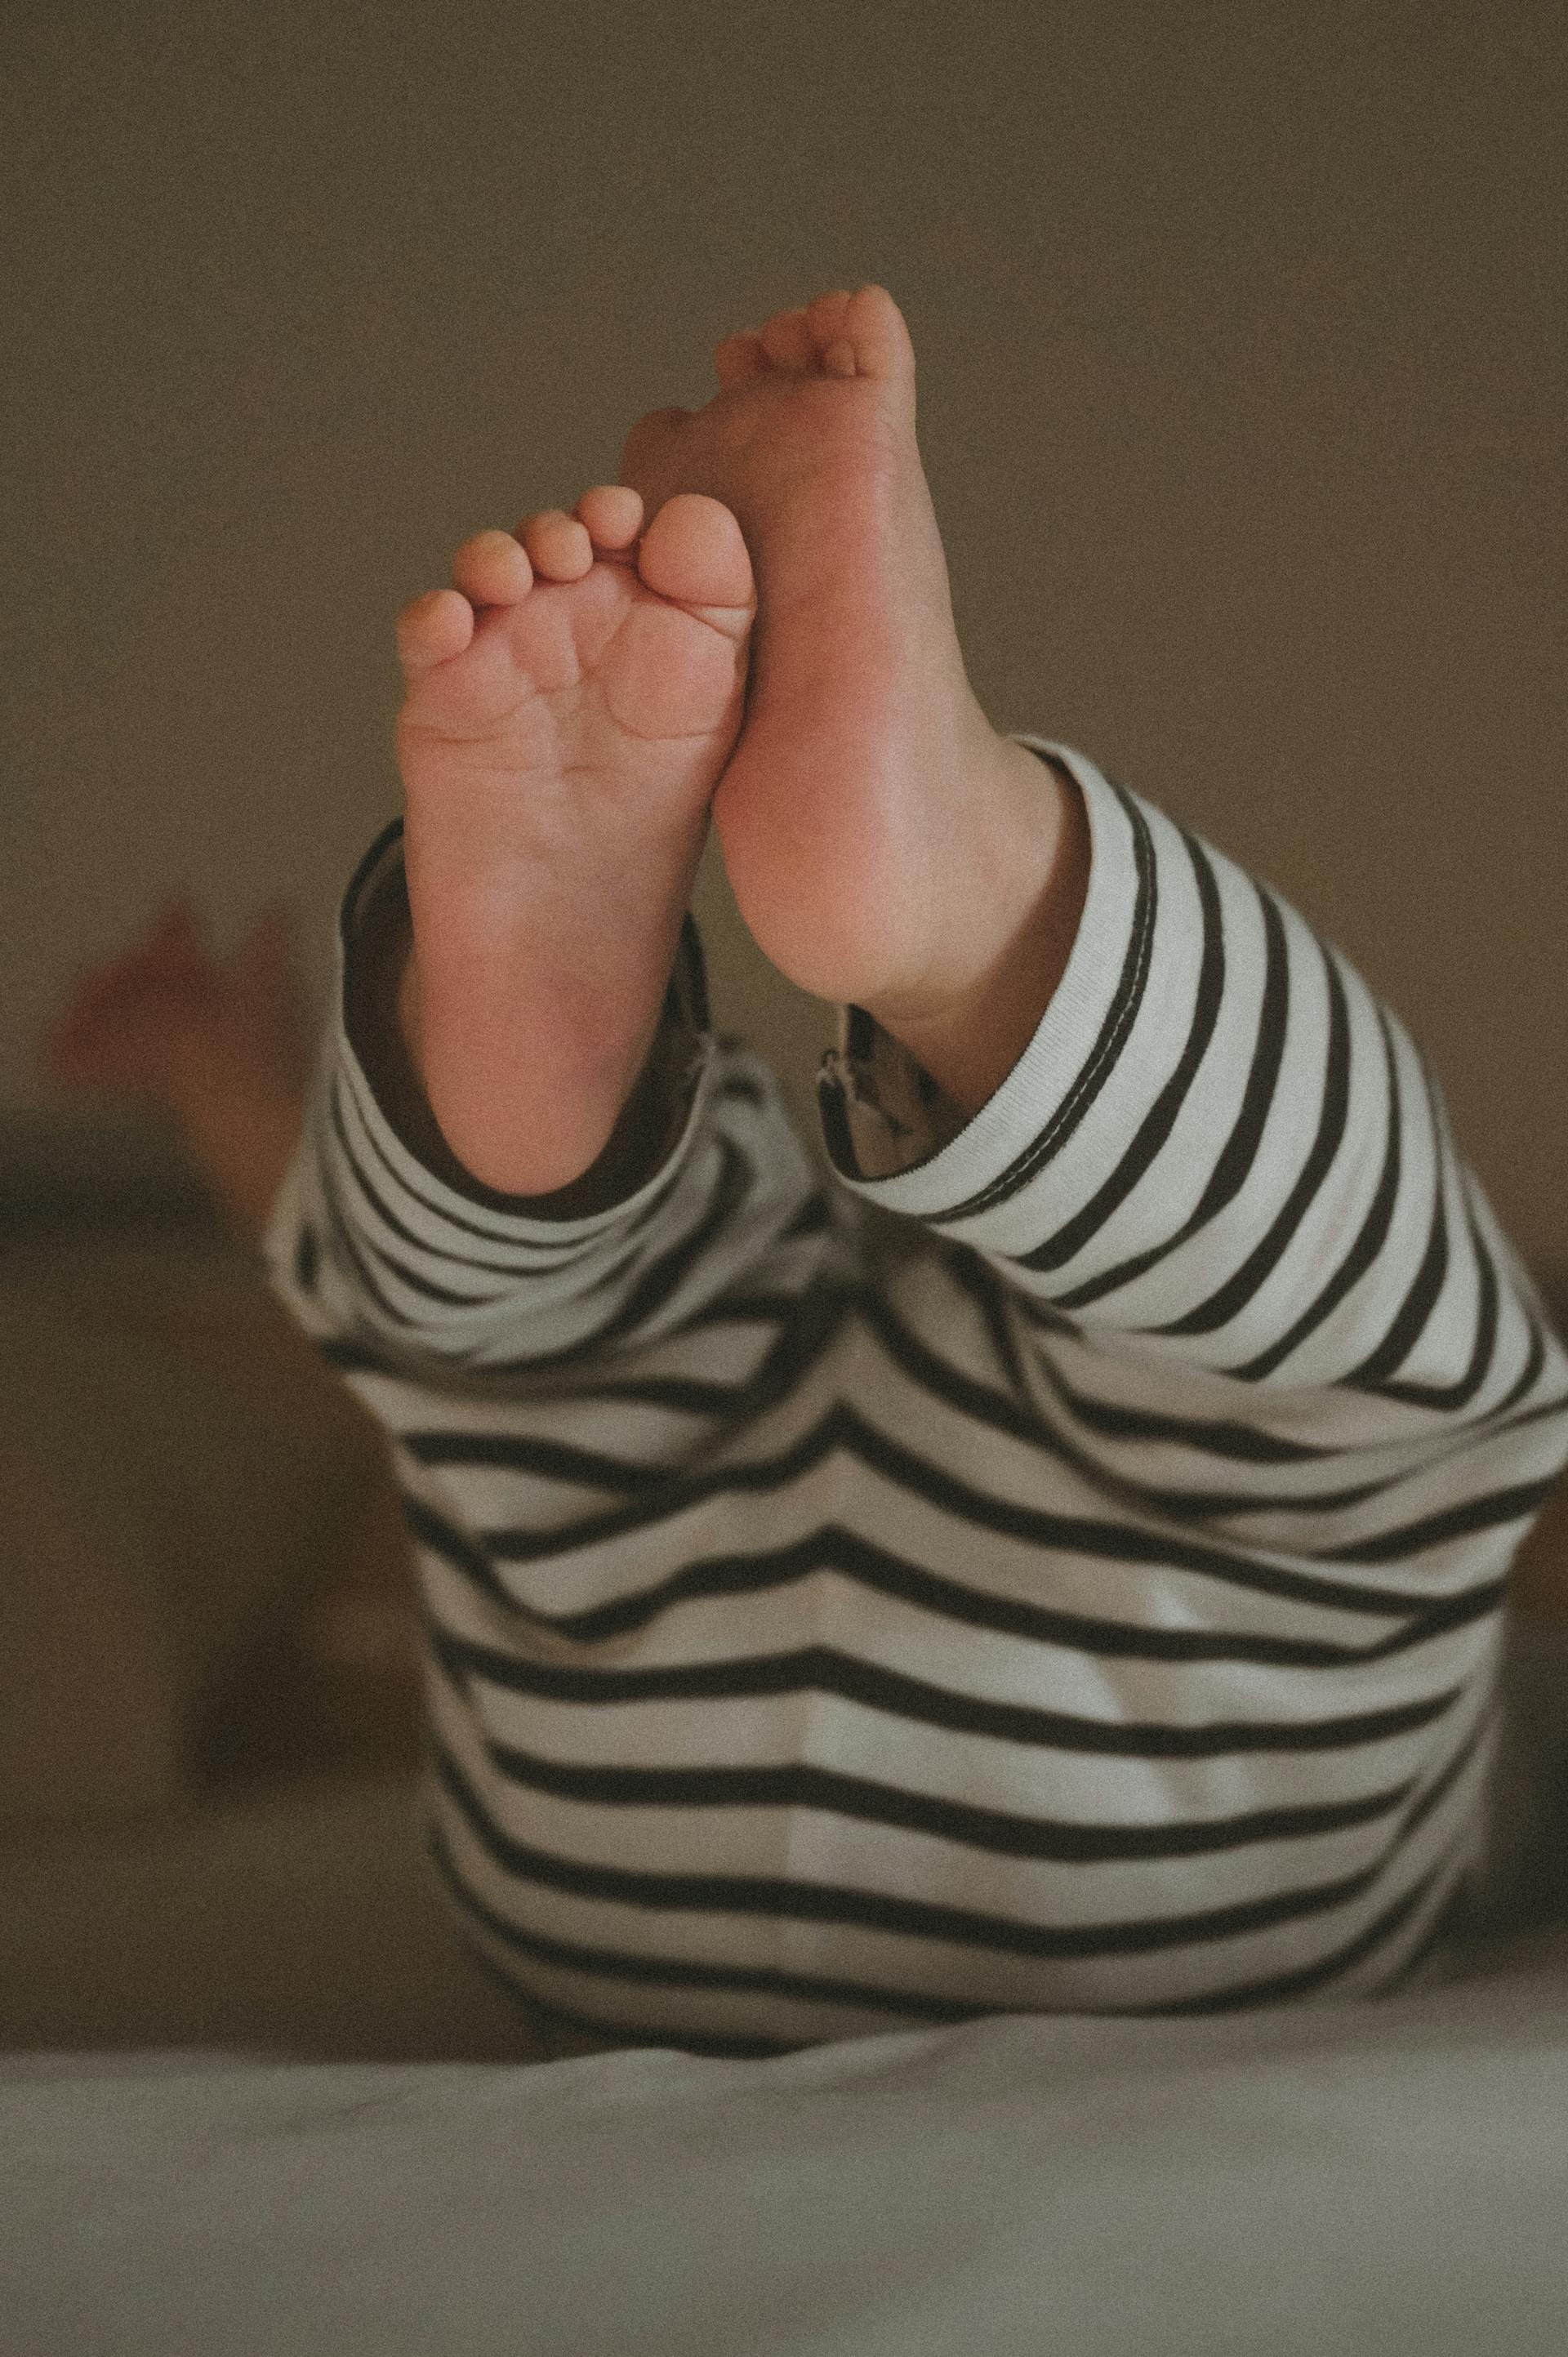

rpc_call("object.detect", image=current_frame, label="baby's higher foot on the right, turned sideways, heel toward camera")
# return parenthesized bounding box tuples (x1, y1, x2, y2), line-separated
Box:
(622, 285, 1056, 1051)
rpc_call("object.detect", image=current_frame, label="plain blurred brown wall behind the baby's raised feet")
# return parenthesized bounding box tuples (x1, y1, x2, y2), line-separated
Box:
(0, 0, 1568, 1266)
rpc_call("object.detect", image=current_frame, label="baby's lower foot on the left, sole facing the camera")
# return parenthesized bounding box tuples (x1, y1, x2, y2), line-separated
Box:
(396, 483, 757, 1195)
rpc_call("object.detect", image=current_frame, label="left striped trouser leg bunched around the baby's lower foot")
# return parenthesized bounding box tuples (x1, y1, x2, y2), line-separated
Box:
(264, 825, 835, 1385)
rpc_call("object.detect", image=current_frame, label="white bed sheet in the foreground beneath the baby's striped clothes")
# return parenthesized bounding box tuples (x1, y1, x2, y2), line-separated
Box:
(0, 1933, 1568, 2357)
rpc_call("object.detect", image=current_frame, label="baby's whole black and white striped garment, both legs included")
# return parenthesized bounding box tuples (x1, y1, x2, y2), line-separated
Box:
(266, 735, 1568, 2056)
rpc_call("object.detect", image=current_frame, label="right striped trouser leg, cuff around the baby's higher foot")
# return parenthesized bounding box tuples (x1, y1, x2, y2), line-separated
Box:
(818, 737, 1566, 1582)
